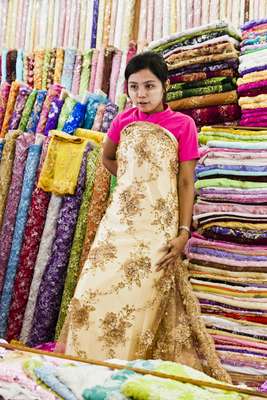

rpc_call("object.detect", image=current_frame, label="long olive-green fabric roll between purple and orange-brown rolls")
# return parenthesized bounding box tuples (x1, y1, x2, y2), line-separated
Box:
(56, 147, 100, 339)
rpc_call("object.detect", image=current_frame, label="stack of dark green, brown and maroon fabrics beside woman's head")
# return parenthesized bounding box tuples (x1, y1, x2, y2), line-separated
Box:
(149, 22, 243, 125)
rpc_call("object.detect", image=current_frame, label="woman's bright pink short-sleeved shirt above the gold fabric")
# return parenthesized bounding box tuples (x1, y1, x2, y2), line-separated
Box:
(108, 107, 199, 162)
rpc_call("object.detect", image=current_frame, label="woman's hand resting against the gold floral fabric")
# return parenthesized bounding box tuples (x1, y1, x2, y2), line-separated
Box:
(156, 232, 189, 271)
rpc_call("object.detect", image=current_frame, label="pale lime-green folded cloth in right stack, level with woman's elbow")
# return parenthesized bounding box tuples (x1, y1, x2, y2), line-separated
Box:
(195, 178, 267, 190)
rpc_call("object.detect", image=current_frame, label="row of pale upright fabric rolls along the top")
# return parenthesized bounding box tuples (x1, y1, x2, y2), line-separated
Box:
(0, 0, 267, 52)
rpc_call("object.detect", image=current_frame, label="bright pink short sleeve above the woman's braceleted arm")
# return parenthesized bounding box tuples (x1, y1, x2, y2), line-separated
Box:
(179, 118, 199, 162)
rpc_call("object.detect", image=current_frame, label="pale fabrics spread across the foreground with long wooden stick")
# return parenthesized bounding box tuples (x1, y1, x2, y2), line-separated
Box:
(0, 343, 267, 400)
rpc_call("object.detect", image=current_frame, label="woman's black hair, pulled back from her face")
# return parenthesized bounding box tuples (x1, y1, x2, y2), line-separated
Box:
(124, 51, 168, 89)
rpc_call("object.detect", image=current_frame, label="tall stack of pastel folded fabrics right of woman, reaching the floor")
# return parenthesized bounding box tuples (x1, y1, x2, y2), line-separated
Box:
(187, 127, 267, 386)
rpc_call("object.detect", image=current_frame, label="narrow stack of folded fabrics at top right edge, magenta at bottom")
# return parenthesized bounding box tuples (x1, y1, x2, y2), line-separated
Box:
(237, 19, 267, 127)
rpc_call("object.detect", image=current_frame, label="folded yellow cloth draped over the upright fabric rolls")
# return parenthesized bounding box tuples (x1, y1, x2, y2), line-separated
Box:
(38, 130, 88, 195)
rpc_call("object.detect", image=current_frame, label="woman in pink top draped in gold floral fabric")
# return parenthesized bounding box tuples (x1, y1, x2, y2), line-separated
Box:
(58, 53, 230, 381)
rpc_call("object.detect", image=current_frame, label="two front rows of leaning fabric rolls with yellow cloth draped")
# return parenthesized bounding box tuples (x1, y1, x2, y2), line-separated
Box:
(0, 81, 118, 345)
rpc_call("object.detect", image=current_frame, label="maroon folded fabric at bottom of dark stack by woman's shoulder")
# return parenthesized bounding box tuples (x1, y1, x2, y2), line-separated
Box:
(182, 104, 240, 125)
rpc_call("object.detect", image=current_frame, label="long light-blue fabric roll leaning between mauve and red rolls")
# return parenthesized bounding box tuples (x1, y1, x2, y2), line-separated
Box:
(0, 144, 42, 337)
